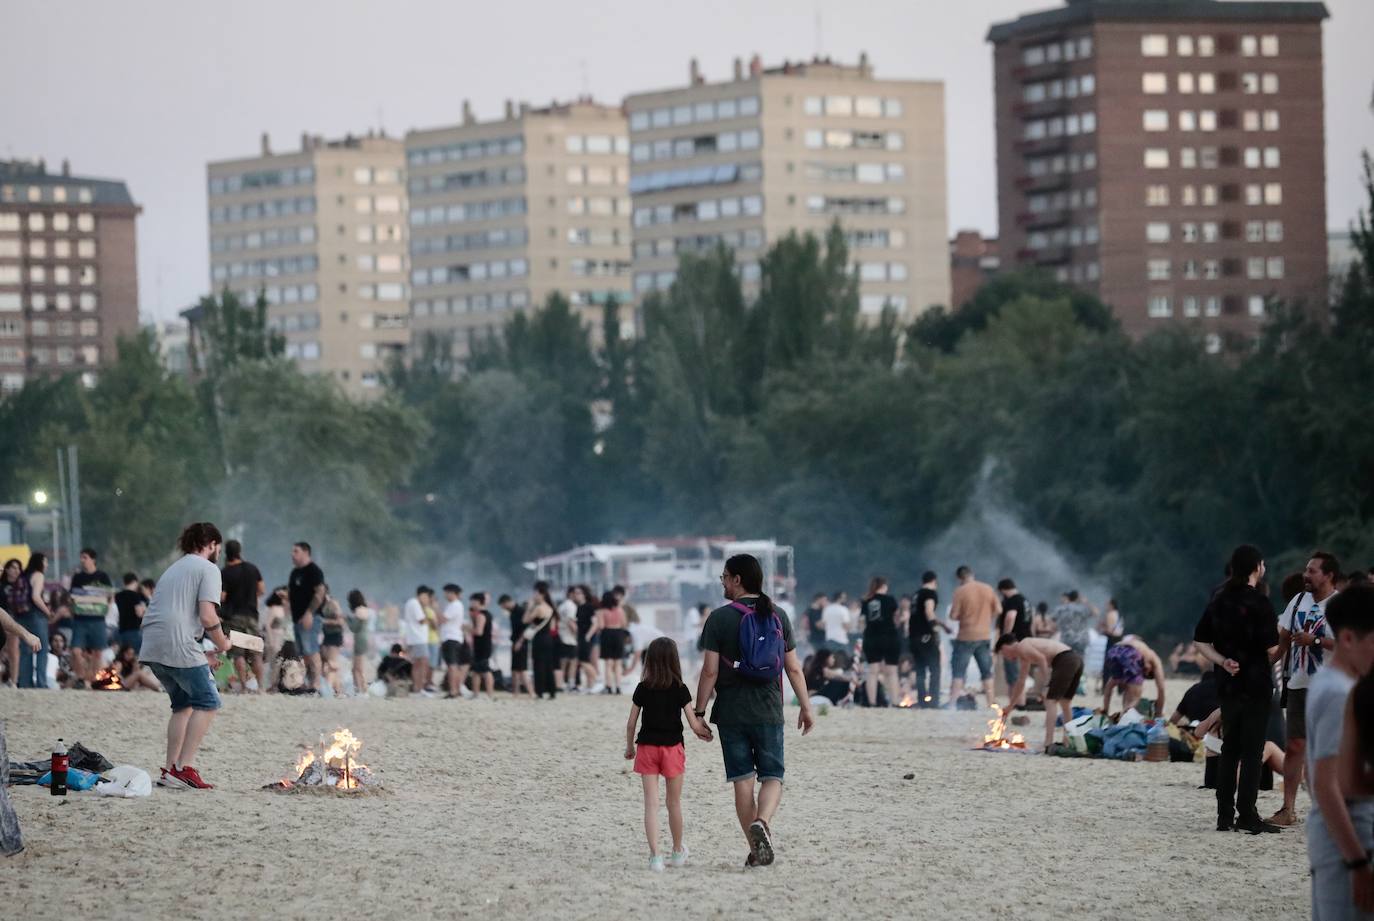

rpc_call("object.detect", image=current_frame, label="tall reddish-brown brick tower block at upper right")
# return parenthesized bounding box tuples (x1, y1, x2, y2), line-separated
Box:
(988, 0, 1326, 351)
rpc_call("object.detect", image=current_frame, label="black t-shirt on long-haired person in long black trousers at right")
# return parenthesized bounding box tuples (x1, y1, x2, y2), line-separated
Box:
(1193, 583, 1279, 701)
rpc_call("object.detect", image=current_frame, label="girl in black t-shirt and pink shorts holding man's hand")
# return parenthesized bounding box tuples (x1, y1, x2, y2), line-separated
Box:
(625, 636, 712, 873)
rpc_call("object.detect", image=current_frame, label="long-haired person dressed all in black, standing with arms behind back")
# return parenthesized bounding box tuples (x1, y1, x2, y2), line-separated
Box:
(1193, 544, 1279, 834)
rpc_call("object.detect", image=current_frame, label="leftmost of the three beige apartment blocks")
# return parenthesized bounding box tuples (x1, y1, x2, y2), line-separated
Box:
(206, 135, 409, 395)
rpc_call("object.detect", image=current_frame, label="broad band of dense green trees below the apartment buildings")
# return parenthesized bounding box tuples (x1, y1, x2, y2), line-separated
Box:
(0, 161, 1374, 634)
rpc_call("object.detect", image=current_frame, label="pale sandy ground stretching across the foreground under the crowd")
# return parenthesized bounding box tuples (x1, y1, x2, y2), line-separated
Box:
(0, 683, 1308, 921)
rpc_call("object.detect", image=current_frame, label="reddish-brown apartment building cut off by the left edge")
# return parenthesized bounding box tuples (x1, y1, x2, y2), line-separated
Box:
(0, 161, 142, 392)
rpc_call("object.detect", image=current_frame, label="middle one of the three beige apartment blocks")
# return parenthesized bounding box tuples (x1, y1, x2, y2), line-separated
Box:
(405, 98, 632, 363)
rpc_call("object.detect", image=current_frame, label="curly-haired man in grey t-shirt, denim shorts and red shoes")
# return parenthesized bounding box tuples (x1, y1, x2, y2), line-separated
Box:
(140, 521, 229, 790)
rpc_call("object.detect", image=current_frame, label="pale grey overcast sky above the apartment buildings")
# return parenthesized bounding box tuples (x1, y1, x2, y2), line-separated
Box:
(0, 0, 1374, 318)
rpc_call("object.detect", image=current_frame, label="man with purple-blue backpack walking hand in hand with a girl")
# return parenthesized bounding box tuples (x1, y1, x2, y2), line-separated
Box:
(695, 554, 815, 869)
